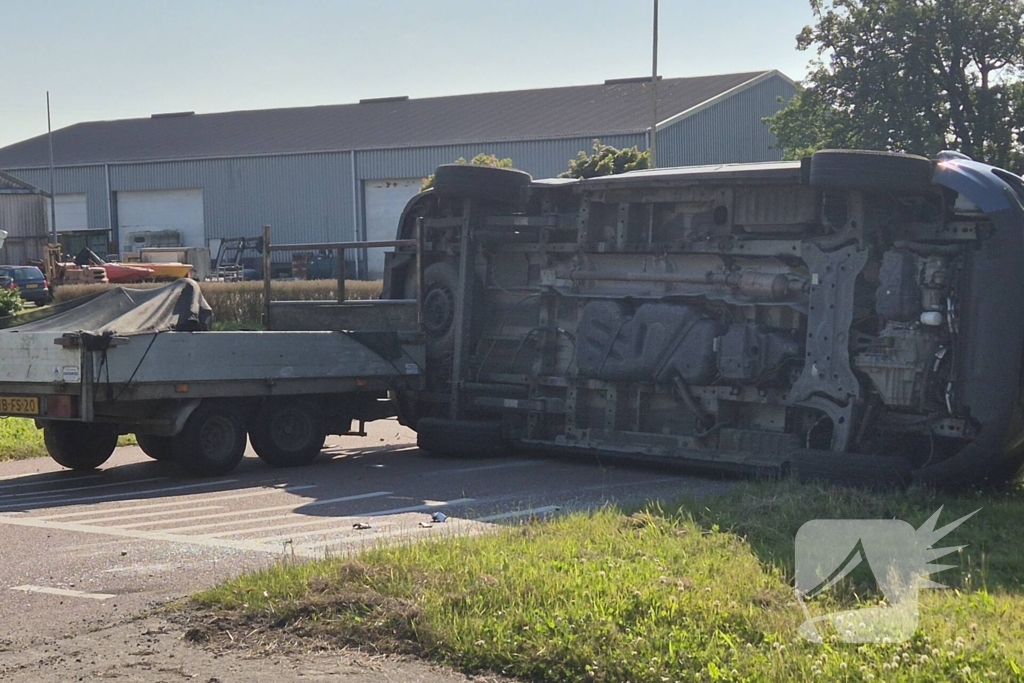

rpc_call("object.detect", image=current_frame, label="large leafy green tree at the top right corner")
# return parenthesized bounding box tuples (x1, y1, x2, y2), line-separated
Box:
(768, 0, 1024, 169)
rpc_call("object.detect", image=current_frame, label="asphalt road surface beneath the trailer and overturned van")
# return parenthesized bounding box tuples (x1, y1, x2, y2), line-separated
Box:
(0, 421, 730, 681)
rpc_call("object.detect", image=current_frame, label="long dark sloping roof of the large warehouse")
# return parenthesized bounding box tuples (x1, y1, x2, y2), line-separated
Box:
(0, 72, 784, 169)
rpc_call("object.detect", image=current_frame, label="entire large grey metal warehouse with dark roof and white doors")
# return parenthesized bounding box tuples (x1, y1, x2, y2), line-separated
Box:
(0, 71, 796, 276)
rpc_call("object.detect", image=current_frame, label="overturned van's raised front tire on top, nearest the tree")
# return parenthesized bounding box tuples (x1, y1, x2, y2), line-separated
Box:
(810, 150, 934, 191)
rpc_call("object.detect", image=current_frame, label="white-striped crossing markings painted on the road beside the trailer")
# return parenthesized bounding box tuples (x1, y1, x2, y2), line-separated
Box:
(0, 463, 557, 557)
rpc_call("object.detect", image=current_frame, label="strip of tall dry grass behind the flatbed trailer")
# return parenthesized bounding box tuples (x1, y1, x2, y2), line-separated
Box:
(54, 280, 382, 325)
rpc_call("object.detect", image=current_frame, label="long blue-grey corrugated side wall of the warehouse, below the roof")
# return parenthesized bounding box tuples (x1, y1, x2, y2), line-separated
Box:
(4, 135, 646, 243)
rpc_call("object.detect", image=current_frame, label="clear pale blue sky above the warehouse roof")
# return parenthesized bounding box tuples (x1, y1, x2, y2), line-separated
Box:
(0, 0, 811, 146)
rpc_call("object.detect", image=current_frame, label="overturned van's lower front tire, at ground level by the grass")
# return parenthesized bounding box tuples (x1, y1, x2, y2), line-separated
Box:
(790, 450, 913, 489)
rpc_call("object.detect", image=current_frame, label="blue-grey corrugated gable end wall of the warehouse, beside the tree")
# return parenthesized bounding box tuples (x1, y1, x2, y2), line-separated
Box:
(657, 76, 797, 167)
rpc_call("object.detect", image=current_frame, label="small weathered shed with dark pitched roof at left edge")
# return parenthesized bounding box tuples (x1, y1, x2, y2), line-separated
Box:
(0, 173, 49, 265)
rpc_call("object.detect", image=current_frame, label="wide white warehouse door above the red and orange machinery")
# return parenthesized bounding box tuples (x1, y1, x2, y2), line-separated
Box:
(118, 189, 206, 253)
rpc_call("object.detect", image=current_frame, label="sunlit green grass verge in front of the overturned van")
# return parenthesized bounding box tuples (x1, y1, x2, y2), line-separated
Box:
(190, 482, 1024, 683)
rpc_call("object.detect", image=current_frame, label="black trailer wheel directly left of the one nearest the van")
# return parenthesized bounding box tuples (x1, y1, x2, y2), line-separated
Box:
(171, 403, 246, 476)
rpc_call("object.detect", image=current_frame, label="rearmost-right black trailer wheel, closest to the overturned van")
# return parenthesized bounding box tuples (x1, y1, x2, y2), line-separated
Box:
(249, 399, 325, 467)
